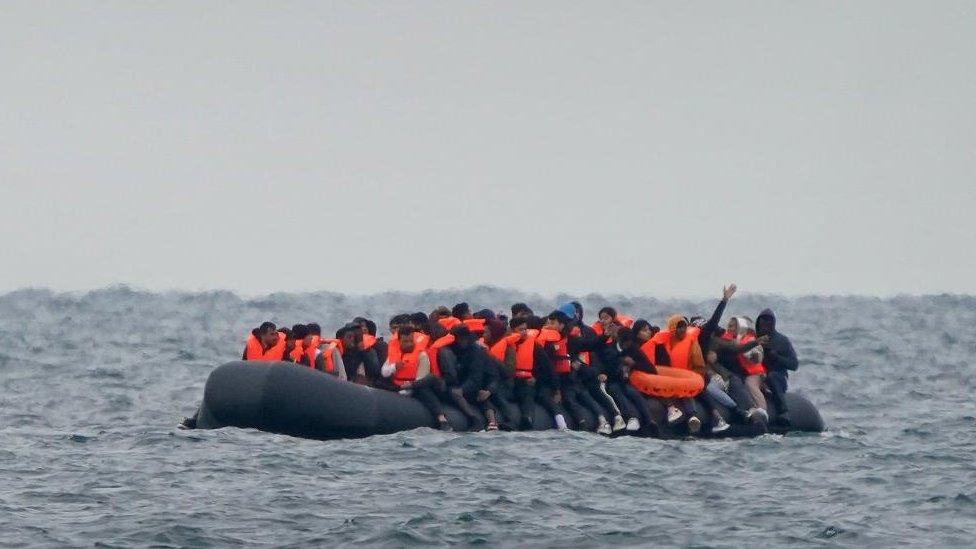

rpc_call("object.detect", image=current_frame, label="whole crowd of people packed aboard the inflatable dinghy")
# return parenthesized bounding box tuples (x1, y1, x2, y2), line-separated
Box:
(202, 284, 798, 435)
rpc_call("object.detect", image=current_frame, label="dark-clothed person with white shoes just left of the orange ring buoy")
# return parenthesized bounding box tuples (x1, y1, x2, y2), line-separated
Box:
(598, 322, 657, 434)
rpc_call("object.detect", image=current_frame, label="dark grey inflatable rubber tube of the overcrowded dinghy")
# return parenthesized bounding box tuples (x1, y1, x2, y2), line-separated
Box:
(197, 361, 824, 440)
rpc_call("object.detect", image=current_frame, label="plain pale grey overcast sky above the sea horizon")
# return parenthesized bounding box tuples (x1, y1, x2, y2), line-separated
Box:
(0, 1, 976, 296)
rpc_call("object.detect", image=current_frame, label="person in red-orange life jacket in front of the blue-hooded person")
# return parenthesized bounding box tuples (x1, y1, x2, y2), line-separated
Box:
(540, 310, 606, 430)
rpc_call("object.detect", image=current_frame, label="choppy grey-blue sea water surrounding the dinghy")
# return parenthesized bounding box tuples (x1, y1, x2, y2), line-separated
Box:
(0, 288, 976, 547)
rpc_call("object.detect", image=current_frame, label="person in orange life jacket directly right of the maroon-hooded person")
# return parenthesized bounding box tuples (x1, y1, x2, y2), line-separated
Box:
(509, 315, 568, 430)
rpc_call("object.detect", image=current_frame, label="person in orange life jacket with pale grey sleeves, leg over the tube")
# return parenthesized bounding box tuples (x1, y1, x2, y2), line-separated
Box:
(381, 328, 451, 431)
